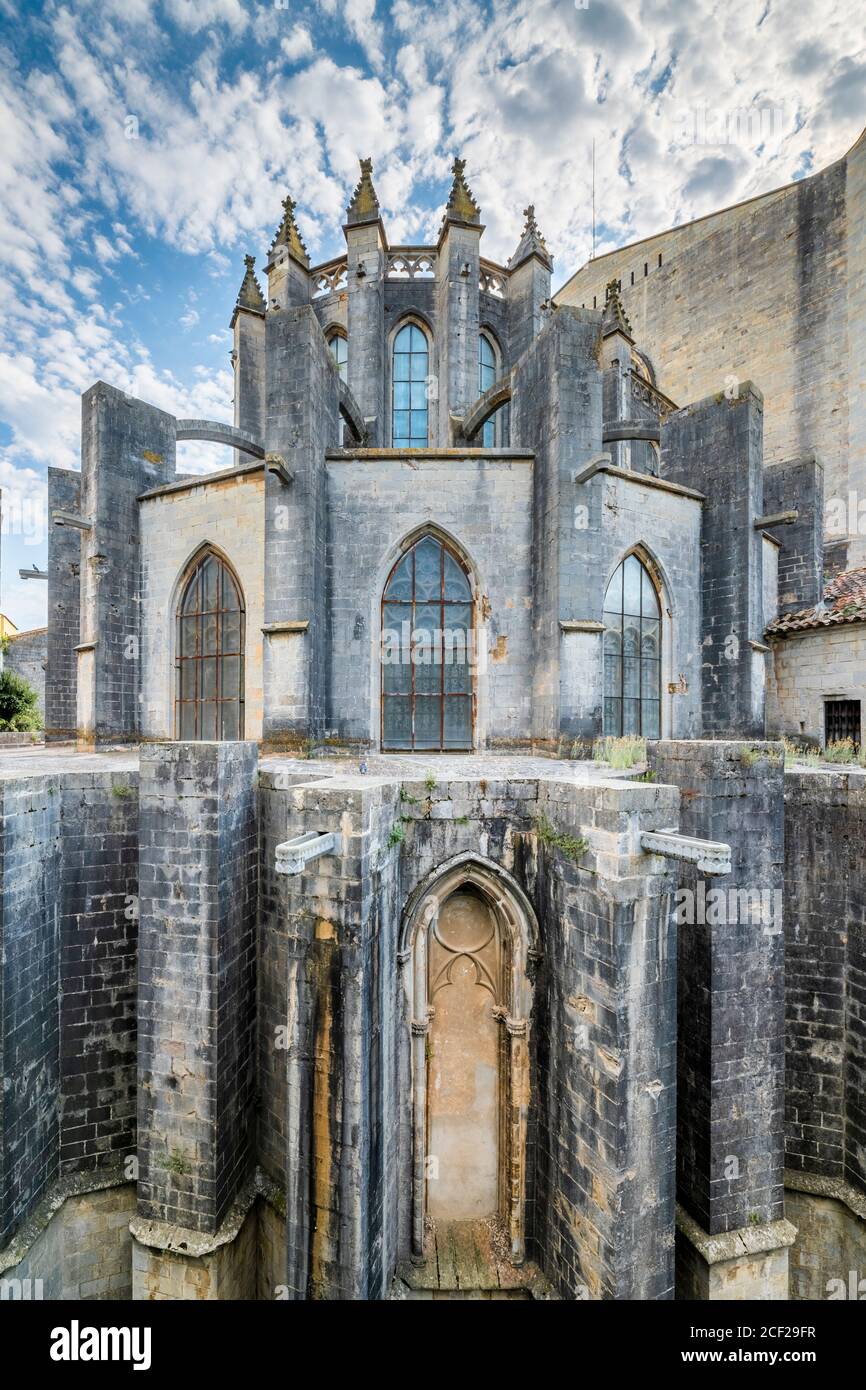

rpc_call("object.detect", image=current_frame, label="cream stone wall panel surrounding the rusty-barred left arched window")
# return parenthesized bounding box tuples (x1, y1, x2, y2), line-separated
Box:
(140, 471, 264, 738)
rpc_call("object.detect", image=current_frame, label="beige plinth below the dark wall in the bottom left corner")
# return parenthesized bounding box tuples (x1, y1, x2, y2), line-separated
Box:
(0, 1183, 135, 1301)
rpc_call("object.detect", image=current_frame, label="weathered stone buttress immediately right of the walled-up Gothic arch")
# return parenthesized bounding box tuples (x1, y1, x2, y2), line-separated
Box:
(534, 784, 677, 1300)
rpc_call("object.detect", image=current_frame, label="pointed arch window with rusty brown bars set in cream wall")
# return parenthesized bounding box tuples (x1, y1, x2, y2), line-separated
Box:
(175, 550, 246, 739)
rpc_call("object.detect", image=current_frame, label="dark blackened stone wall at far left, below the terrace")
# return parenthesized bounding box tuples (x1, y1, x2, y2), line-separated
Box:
(0, 769, 138, 1247)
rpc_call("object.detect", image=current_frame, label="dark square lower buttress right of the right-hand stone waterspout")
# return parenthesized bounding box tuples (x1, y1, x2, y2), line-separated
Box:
(648, 741, 784, 1236)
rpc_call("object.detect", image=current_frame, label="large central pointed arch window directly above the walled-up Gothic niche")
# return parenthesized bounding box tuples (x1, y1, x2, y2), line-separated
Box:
(381, 535, 474, 751)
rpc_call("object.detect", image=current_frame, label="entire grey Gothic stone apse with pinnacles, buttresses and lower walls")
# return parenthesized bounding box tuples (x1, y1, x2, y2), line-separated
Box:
(0, 160, 866, 1301)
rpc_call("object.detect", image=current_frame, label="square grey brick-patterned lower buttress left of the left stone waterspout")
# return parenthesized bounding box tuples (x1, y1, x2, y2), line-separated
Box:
(138, 742, 257, 1233)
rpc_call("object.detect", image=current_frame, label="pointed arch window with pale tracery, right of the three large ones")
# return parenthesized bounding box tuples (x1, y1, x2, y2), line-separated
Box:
(603, 555, 662, 738)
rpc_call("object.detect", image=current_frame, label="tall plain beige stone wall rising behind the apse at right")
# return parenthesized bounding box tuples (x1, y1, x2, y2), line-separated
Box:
(556, 136, 866, 566)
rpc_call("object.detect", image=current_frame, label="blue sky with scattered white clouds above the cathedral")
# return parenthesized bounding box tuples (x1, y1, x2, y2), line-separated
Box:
(0, 0, 866, 627)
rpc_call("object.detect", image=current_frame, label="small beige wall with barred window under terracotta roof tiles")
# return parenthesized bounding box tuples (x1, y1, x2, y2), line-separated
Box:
(767, 623, 866, 744)
